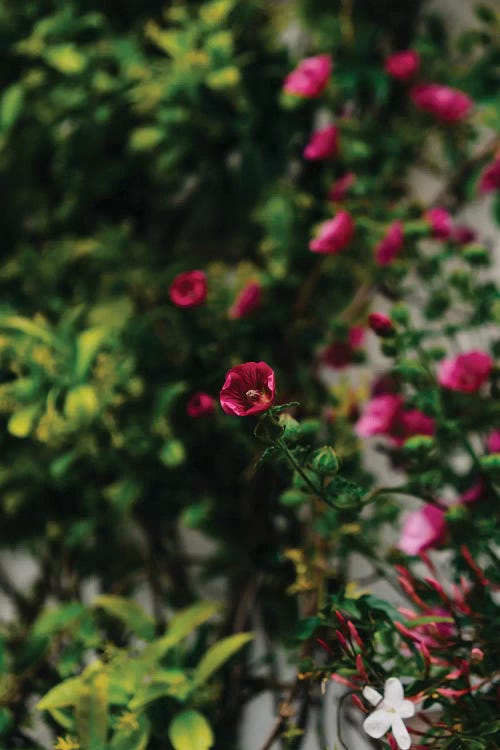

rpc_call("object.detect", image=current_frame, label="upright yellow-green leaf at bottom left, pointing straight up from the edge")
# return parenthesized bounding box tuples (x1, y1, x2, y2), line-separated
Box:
(75, 671, 109, 750)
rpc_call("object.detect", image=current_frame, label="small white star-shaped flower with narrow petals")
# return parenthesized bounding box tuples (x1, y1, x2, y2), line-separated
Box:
(363, 677, 415, 750)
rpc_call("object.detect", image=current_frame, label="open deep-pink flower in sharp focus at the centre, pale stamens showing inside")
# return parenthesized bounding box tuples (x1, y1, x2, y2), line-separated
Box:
(220, 362, 276, 417)
